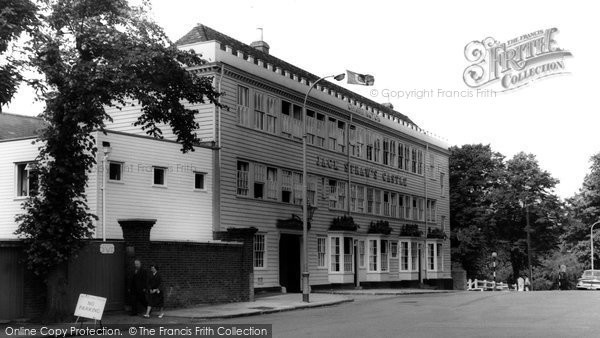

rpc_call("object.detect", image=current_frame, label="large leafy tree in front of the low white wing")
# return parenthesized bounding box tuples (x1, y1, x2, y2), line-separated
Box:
(16, 0, 219, 320)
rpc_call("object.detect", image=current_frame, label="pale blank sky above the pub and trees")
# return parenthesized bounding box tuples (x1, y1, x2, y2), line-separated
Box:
(6, 0, 600, 198)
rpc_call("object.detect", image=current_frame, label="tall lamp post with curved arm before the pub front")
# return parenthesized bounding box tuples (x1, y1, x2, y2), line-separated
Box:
(302, 73, 346, 303)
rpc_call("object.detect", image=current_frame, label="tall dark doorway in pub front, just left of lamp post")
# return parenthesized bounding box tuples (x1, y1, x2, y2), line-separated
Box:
(279, 234, 302, 292)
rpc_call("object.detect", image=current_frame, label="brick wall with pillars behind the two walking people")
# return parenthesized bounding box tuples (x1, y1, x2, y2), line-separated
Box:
(119, 220, 256, 307)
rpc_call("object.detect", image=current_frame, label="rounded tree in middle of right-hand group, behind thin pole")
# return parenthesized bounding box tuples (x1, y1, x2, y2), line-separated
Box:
(492, 152, 566, 278)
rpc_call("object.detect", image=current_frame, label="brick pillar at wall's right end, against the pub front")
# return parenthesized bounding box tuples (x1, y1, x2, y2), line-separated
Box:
(214, 228, 258, 302)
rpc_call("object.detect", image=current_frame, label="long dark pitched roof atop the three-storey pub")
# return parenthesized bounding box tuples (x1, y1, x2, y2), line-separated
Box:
(175, 24, 416, 126)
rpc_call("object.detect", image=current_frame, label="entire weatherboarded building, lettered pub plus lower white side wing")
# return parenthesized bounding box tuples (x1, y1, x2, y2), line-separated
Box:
(0, 25, 451, 291)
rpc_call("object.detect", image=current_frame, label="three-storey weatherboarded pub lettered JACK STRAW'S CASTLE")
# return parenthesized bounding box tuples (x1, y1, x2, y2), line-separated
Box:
(165, 25, 451, 292)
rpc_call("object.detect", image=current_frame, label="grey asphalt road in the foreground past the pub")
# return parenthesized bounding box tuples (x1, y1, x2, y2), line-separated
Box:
(206, 291, 600, 337)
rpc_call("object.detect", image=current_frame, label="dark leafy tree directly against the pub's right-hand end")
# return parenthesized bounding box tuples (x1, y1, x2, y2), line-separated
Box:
(449, 144, 504, 277)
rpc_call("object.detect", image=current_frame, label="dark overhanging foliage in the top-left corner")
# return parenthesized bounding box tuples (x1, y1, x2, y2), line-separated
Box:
(0, 0, 38, 112)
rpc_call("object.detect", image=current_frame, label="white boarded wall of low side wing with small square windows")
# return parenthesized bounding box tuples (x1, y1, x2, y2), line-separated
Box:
(0, 131, 213, 242)
